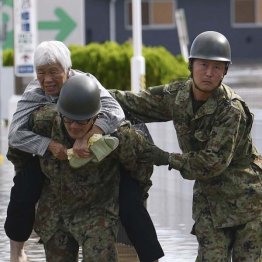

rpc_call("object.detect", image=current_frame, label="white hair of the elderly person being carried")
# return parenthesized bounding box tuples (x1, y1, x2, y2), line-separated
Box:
(34, 41, 72, 72)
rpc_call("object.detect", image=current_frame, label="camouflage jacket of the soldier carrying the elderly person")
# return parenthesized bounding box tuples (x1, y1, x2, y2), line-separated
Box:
(22, 107, 153, 243)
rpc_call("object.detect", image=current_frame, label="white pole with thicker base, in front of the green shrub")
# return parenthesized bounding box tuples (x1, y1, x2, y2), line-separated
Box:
(131, 0, 145, 92)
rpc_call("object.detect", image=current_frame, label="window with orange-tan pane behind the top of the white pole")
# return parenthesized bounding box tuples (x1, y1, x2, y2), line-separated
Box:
(126, 0, 176, 29)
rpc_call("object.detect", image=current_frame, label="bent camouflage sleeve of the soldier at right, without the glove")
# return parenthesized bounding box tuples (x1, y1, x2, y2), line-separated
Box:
(169, 102, 247, 180)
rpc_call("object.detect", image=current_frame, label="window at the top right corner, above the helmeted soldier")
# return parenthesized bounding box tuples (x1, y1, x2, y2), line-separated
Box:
(232, 0, 262, 26)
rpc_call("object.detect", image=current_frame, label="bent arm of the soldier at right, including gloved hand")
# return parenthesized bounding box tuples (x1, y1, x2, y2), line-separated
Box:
(137, 99, 251, 180)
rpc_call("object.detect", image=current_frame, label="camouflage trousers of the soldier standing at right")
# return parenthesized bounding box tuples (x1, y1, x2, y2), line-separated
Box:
(193, 213, 262, 262)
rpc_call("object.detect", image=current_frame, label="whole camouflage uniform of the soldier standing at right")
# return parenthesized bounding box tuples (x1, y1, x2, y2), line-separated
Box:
(114, 80, 262, 261)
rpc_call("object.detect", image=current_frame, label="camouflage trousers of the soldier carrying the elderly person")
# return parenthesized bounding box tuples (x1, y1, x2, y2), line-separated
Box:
(44, 227, 118, 262)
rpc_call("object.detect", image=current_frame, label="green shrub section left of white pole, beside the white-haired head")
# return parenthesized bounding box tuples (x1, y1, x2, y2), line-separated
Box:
(69, 42, 131, 90)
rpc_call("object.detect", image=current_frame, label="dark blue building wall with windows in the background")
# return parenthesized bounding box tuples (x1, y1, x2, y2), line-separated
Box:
(85, 0, 262, 61)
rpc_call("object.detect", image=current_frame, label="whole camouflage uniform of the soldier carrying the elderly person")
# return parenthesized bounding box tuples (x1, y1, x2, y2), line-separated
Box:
(9, 107, 153, 262)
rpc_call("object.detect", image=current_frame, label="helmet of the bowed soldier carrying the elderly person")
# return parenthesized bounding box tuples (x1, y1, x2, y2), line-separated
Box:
(57, 75, 101, 120)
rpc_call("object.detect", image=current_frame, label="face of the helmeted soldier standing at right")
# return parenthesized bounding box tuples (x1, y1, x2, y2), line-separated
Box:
(193, 59, 226, 93)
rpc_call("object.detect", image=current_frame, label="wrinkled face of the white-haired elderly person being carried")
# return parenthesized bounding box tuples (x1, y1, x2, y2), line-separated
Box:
(36, 63, 68, 96)
